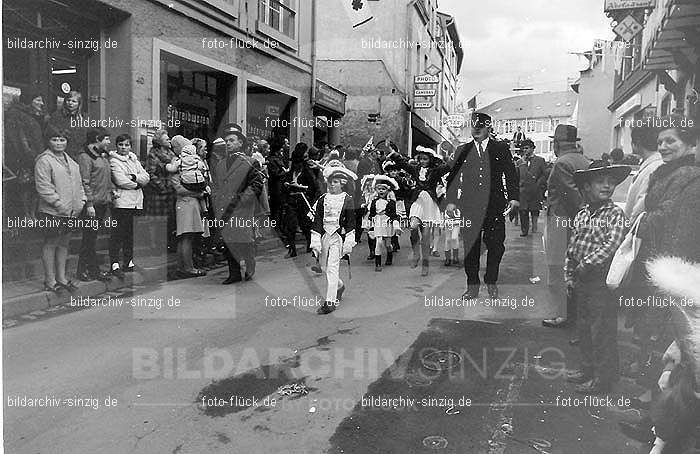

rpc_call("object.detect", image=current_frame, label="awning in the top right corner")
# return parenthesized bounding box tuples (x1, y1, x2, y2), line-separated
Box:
(643, 0, 700, 71)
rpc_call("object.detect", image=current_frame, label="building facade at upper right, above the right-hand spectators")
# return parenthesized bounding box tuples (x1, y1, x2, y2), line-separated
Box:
(606, 0, 700, 153)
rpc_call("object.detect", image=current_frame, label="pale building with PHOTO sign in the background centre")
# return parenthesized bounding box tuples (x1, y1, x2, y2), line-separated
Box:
(315, 0, 463, 154)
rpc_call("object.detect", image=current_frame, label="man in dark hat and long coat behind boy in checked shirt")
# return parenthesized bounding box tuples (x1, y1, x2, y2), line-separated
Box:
(542, 125, 590, 328)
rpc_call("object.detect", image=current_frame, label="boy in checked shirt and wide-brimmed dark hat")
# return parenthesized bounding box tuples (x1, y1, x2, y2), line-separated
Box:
(565, 160, 631, 394)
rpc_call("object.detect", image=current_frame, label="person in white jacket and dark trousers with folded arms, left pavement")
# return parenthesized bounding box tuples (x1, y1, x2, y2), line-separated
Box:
(109, 134, 150, 279)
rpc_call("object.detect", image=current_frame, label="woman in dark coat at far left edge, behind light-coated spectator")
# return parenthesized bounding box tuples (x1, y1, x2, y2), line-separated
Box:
(3, 91, 47, 218)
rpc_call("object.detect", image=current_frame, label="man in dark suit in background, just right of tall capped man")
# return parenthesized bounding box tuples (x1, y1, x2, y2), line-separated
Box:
(517, 139, 547, 236)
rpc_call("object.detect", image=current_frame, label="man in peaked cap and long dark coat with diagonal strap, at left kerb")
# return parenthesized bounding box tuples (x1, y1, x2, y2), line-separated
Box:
(212, 123, 264, 285)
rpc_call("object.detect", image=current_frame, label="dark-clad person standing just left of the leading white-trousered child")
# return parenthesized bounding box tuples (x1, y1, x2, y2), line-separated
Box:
(282, 143, 321, 258)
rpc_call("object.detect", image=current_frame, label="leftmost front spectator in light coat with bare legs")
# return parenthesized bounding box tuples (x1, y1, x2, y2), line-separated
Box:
(34, 125, 85, 293)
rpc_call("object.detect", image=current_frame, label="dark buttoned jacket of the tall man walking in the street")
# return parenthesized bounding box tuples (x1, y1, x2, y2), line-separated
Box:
(446, 139, 520, 224)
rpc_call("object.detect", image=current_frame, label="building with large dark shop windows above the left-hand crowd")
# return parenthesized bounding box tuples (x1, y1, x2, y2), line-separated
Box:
(3, 0, 315, 160)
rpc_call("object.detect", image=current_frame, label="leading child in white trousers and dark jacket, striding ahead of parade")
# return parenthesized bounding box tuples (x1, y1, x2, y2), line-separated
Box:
(311, 167, 357, 315)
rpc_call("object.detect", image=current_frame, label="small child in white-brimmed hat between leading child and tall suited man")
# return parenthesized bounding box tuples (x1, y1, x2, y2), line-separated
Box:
(369, 175, 401, 271)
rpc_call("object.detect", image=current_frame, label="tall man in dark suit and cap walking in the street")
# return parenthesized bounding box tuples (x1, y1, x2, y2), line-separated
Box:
(446, 112, 520, 298)
